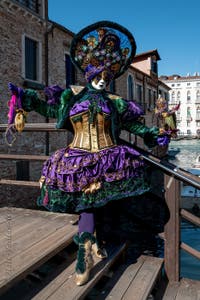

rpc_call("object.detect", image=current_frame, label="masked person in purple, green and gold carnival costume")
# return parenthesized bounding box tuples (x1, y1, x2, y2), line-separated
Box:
(7, 21, 170, 285)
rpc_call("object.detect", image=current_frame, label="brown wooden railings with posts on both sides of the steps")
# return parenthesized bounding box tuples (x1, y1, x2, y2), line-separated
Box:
(0, 123, 200, 282)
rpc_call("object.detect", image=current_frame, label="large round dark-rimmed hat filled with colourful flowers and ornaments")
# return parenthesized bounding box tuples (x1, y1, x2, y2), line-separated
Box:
(70, 21, 136, 81)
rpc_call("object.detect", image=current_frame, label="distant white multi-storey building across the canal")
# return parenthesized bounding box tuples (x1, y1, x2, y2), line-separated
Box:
(160, 73, 200, 136)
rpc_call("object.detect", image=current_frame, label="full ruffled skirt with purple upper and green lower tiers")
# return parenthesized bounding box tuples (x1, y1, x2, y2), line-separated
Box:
(38, 145, 149, 213)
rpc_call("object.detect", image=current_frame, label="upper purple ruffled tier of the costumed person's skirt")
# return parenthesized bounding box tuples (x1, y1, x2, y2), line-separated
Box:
(42, 146, 144, 192)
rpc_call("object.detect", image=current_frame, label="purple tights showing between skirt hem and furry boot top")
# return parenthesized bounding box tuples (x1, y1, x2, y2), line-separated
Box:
(78, 212, 94, 234)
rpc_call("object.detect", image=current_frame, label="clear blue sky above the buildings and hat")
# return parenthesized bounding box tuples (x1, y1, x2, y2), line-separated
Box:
(49, 0, 200, 76)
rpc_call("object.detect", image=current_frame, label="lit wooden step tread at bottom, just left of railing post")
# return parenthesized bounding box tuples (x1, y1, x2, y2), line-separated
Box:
(106, 256, 163, 300)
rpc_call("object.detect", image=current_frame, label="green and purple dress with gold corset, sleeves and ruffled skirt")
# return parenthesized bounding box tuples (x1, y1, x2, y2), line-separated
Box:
(22, 84, 166, 213)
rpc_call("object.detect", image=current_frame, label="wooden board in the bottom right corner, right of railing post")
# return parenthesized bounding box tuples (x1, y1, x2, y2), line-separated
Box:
(176, 278, 200, 300)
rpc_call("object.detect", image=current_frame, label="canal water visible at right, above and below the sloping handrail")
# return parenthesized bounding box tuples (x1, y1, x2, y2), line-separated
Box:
(170, 139, 200, 280)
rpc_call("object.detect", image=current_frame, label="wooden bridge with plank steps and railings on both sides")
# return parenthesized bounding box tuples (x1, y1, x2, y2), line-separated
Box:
(0, 124, 200, 300)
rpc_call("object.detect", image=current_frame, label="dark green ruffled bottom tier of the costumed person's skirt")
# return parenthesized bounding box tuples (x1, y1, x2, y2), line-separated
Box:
(37, 177, 149, 213)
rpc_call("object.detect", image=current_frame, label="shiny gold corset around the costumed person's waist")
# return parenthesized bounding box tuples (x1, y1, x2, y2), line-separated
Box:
(70, 111, 114, 152)
